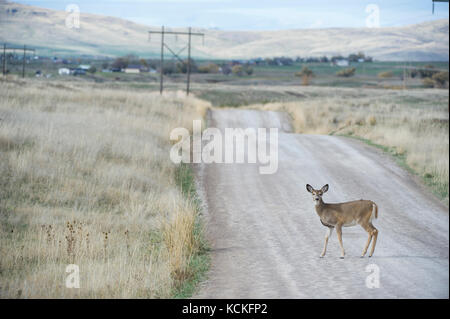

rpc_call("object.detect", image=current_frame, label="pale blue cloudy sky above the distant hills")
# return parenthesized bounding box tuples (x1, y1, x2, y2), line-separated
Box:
(12, 0, 449, 30)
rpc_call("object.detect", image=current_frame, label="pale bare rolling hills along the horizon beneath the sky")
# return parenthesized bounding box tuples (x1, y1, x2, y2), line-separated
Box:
(0, 0, 449, 61)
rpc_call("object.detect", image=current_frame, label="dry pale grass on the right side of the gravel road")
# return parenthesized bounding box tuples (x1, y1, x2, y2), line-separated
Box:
(250, 88, 449, 205)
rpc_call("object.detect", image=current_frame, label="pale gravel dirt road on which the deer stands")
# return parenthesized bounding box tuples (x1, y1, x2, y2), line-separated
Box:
(196, 109, 449, 298)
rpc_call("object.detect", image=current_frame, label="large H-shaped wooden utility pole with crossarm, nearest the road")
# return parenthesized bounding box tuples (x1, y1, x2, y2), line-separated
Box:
(148, 26, 205, 95)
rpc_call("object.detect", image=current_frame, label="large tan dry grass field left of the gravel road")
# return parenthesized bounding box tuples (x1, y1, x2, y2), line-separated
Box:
(0, 79, 209, 298)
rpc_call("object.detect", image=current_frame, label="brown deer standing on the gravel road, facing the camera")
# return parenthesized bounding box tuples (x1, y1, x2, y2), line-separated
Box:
(306, 184, 378, 259)
